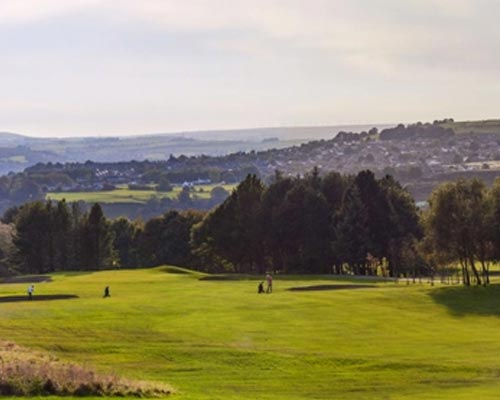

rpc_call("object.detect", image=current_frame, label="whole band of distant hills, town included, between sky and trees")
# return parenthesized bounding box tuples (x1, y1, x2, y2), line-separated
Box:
(0, 119, 500, 215)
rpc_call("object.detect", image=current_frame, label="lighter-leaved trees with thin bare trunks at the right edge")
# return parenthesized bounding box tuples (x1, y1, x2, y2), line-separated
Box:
(420, 178, 500, 285)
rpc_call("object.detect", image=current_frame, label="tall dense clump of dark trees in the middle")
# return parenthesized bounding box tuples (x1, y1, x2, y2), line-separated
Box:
(191, 169, 422, 276)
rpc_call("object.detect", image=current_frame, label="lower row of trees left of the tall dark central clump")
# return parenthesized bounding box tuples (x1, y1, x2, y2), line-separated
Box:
(0, 200, 203, 274)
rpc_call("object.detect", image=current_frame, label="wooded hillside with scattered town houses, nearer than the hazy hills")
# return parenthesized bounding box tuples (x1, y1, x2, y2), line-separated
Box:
(11, 120, 500, 201)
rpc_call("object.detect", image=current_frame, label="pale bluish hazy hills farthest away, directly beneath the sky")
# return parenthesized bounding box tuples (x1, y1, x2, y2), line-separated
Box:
(0, 125, 385, 174)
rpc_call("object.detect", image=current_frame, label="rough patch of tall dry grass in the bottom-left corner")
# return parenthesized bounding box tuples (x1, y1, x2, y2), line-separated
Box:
(0, 342, 172, 397)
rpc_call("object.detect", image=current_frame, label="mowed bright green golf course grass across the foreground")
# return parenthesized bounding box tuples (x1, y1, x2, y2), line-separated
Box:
(0, 267, 500, 400)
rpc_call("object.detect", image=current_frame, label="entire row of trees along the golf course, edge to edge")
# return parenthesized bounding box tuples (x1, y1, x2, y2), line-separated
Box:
(0, 168, 500, 285)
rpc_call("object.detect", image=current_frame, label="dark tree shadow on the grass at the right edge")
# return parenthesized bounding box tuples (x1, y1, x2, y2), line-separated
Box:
(429, 284, 500, 317)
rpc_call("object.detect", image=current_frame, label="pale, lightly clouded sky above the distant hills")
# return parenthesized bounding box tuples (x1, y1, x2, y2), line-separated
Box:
(0, 0, 500, 136)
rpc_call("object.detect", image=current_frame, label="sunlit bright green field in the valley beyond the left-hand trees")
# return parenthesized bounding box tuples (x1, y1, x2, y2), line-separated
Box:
(46, 185, 235, 204)
